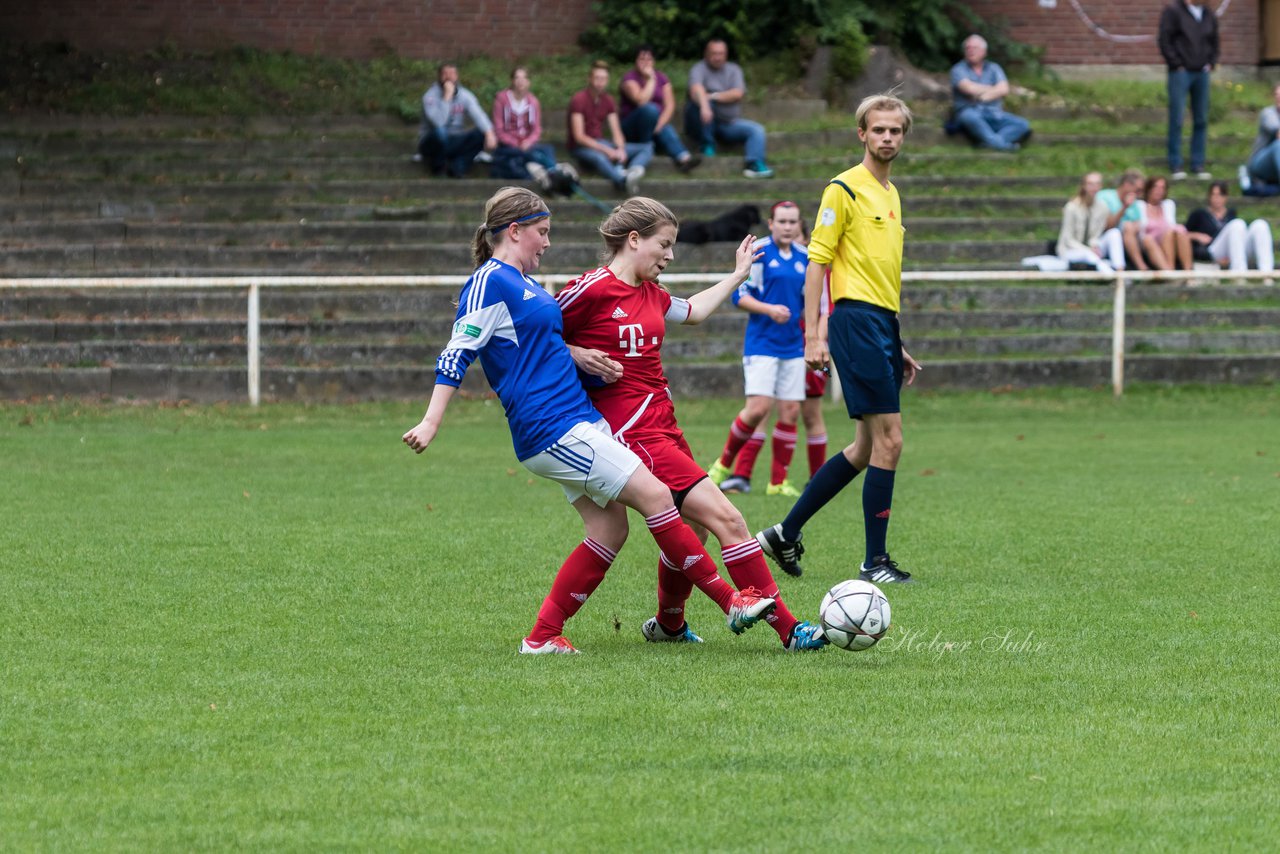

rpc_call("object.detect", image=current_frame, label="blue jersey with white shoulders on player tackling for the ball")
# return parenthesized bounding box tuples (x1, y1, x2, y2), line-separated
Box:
(435, 259, 600, 460)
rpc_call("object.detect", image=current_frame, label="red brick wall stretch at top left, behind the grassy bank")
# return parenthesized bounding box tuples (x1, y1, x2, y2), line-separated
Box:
(0, 0, 591, 59)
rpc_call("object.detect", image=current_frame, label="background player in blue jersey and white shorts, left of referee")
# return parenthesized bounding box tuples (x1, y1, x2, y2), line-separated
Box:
(707, 201, 809, 498)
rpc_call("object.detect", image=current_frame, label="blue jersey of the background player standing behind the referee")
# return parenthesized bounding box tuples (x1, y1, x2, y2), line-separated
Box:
(733, 237, 809, 359)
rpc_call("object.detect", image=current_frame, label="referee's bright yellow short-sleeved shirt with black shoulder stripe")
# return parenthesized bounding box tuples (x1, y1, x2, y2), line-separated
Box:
(809, 164, 904, 314)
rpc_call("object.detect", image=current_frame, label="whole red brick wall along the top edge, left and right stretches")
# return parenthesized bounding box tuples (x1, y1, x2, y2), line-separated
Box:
(0, 0, 1262, 65)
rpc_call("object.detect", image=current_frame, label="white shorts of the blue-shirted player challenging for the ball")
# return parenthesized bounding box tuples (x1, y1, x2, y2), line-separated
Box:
(524, 419, 640, 507)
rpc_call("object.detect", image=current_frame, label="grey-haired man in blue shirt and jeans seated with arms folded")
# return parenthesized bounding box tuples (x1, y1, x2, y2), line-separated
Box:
(951, 33, 1032, 151)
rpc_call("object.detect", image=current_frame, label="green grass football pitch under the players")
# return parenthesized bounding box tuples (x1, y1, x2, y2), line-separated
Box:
(0, 391, 1280, 851)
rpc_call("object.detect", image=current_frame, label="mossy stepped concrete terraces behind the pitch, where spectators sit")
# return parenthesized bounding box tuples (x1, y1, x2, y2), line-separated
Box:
(0, 112, 1280, 401)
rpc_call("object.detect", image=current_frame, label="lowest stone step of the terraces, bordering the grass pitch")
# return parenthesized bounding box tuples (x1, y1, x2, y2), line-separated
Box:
(0, 355, 1280, 407)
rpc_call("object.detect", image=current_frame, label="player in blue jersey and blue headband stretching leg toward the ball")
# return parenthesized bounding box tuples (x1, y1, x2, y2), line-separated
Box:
(403, 187, 776, 654)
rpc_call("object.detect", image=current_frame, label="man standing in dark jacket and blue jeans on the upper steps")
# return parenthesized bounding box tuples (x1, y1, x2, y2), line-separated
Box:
(1160, 0, 1217, 181)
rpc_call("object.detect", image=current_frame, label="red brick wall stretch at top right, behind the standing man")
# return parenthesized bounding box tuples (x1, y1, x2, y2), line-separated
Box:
(956, 0, 1262, 65)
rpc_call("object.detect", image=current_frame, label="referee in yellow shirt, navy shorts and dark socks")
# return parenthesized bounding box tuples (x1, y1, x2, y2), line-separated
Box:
(756, 95, 920, 584)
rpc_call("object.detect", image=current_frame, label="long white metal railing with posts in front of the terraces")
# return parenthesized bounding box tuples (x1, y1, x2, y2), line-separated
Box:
(0, 270, 1275, 406)
